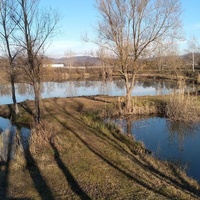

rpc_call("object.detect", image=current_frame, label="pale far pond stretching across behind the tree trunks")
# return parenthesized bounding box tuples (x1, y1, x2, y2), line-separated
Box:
(0, 79, 198, 105)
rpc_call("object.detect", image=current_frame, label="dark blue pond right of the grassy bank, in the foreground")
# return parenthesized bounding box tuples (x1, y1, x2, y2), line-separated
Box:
(116, 117, 200, 181)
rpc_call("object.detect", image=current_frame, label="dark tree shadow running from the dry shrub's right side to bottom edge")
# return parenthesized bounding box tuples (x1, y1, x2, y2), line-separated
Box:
(50, 141, 91, 200)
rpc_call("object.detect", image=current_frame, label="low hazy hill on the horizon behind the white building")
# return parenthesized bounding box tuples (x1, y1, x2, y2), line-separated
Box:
(51, 56, 101, 66)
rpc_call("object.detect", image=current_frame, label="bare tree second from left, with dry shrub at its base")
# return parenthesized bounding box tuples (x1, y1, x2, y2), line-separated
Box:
(12, 0, 59, 122)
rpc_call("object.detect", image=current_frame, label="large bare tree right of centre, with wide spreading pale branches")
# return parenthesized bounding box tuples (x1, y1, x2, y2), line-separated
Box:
(95, 0, 181, 113)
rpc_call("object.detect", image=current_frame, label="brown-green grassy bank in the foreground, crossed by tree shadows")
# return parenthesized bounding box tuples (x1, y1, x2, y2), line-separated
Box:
(0, 97, 200, 199)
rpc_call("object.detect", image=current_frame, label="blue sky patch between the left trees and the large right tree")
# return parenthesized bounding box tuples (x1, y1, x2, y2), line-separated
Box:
(40, 0, 97, 57)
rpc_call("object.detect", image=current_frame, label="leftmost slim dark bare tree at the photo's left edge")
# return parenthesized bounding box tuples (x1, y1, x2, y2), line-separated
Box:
(0, 0, 20, 114)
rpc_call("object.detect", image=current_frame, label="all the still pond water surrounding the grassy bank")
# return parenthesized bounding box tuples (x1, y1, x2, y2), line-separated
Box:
(0, 80, 200, 180)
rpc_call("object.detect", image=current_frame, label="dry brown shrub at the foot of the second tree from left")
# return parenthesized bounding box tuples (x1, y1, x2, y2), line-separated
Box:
(30, 121, 55, 153)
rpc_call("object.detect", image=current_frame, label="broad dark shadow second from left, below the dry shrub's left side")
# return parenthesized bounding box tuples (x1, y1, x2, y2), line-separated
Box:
(20, 140, 55, 200)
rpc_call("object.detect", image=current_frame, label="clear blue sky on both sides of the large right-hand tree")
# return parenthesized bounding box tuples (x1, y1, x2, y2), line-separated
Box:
(40, 0, 200, 58)
